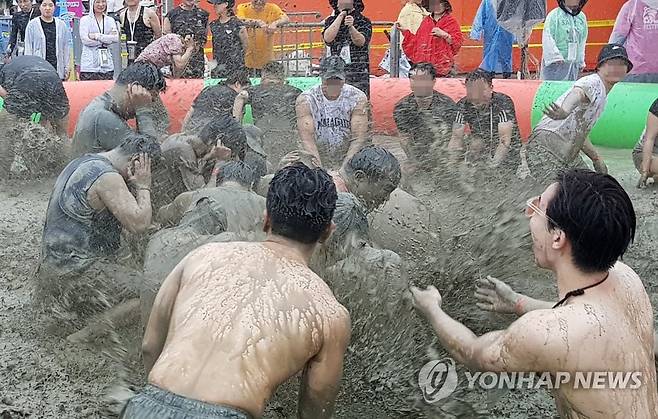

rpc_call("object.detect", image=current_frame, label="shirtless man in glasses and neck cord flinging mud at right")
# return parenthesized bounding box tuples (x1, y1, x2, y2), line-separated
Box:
(411, 170, 658, 418)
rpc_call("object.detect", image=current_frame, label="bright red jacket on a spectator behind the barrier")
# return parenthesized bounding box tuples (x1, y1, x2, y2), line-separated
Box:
(402, 14, 464, 76)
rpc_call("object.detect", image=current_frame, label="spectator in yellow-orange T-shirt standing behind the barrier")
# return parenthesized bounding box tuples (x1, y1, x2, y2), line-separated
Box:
(237, 0, 290, 77)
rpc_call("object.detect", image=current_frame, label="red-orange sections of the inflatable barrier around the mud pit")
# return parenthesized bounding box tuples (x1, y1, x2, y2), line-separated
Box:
(64, 78, 542, 138)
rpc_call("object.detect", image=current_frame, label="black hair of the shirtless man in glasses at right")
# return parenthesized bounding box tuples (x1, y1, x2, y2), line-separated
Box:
(546, 170, 636, 273)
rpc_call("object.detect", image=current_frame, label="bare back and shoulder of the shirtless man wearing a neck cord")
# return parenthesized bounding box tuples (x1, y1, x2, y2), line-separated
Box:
(540, 262, 658, 418)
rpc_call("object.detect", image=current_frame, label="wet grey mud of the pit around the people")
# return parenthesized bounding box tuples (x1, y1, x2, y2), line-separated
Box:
(0, 140, 658, 419)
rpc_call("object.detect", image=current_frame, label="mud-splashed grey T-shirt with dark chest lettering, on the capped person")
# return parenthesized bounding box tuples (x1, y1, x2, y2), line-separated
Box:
(302, 84, 368, 168)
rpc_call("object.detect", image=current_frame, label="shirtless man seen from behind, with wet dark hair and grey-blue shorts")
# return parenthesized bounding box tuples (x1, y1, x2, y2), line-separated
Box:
(121, 164, 350, 419)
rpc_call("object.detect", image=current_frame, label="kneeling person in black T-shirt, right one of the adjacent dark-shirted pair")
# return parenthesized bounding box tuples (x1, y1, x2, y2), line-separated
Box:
(449, 69, 521, 171)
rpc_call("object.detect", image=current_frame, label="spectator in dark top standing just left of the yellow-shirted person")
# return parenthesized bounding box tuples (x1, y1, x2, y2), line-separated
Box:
(210, 0, 247, 79)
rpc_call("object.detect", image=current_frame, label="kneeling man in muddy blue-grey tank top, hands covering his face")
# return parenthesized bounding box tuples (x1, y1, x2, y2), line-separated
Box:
(34, 134, 160, 338)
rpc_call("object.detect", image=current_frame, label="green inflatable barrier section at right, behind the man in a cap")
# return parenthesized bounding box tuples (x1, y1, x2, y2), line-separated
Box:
(532, 81, 658, 149)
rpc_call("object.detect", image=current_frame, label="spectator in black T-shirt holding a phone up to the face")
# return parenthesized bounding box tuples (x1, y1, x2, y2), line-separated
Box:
(322, 0, 372, 97)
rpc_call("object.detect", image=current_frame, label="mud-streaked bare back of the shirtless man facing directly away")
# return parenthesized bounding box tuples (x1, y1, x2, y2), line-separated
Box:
(145, 242, 349, 417)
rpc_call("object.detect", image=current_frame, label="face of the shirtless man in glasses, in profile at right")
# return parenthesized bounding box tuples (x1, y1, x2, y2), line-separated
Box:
(526, 183, 564, 268)
